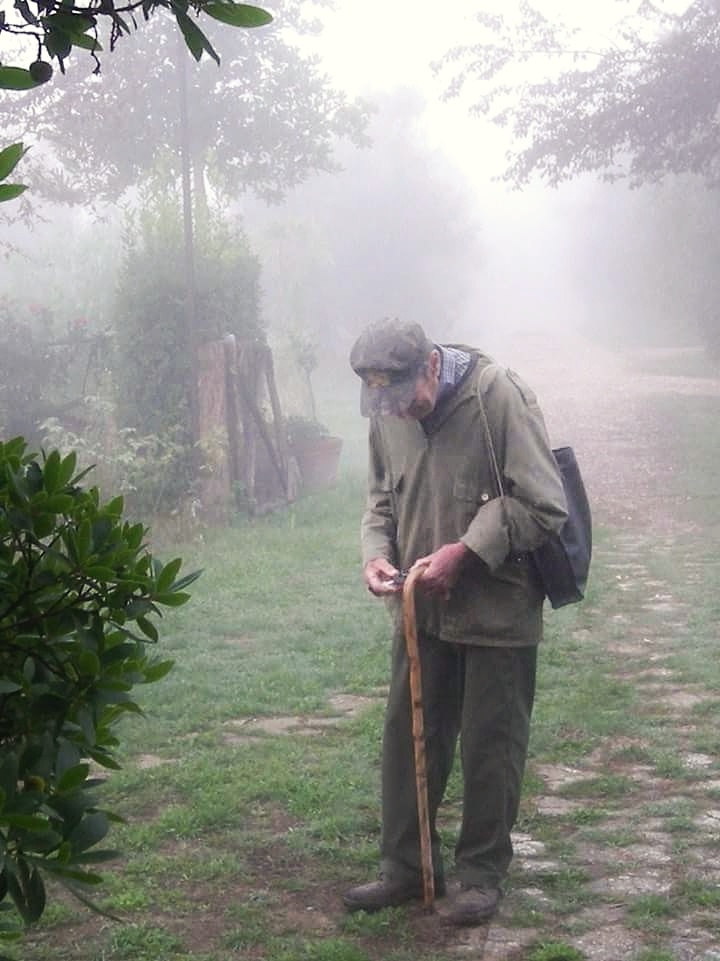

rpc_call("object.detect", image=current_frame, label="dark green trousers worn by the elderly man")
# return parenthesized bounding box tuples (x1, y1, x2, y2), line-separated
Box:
(381, 635, 537, 887)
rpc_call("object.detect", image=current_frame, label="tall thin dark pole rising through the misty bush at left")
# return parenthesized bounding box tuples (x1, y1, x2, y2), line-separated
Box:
(177, 31, 200, 441)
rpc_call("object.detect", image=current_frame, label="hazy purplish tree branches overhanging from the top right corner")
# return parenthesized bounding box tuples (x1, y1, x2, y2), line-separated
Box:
(438, 0, 720, 187)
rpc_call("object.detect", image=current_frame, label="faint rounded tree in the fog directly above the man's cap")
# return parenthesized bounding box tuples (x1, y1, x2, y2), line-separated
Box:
(247, 88, 484, 363)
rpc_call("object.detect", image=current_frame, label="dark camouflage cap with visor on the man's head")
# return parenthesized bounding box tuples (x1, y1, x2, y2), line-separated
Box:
(350, 317, 435, 417)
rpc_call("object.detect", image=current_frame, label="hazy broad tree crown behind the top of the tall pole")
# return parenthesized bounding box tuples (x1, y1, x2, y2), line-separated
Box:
(7, 0, 366, 203)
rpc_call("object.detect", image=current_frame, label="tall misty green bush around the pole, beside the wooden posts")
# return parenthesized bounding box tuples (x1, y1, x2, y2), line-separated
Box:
(115, 177, 264, 509)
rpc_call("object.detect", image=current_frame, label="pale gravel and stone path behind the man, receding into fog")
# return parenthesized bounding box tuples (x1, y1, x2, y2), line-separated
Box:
(455, 338, 720, 961)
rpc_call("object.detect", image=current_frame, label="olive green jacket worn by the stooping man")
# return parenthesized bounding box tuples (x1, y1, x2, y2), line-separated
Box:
(361, 345, 567, 646)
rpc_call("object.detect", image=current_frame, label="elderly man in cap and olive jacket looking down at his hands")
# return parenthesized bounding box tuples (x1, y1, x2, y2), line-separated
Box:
(344, 319, 566, 925)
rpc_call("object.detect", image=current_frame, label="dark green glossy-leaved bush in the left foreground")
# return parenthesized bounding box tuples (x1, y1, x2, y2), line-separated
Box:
(0, 438, 198, 938)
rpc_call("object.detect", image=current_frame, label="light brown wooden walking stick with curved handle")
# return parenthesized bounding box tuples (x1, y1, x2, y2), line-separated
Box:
(402, 565, 435, 911)
